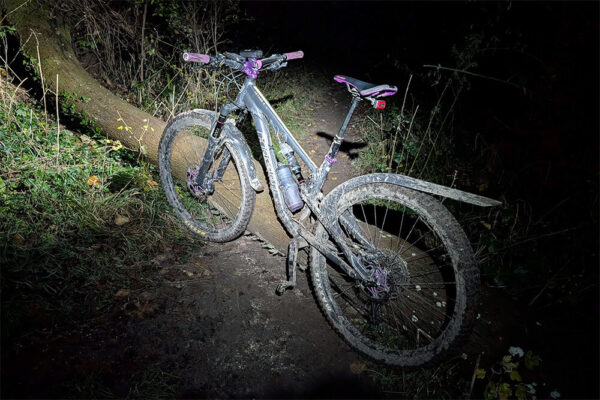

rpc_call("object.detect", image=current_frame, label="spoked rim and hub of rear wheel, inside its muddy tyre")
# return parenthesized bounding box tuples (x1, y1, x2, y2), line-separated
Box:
(321, 191, 464, 364)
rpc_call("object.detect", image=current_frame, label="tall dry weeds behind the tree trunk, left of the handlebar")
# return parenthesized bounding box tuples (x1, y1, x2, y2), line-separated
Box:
(54, 0, 240, 119)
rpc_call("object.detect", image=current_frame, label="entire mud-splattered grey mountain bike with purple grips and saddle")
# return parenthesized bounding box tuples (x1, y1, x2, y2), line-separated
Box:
(158, 50, 500, 366)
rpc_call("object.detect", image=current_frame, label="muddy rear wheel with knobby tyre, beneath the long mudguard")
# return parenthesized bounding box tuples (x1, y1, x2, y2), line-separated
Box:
(311, 182, 479, 367)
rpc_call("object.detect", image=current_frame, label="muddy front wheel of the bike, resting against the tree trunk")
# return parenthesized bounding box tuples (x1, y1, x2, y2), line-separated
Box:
(158, 110, 256, 242)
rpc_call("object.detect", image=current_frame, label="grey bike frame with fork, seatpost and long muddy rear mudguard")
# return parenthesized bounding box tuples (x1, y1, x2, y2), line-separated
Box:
(203, 77, 500, 281)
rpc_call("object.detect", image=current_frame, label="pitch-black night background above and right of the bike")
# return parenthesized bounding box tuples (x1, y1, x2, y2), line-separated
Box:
(237, 2, 600, 397)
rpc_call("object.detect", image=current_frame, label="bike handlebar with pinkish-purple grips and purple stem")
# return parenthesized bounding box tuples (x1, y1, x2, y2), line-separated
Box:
(183, 50, 304, 78)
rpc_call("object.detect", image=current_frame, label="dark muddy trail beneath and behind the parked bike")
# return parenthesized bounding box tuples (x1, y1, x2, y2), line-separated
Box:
(2, 74, 522, 398)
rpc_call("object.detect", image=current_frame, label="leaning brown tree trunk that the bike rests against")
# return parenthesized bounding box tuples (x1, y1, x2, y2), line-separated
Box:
(0, 0, 288, 254)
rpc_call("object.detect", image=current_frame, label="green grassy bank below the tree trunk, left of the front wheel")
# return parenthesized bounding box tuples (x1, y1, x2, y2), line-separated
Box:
(0, 79, 194, 387)
